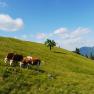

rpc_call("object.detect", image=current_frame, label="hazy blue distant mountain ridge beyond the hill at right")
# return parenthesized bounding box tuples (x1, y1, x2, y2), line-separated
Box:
(80, 47, 94, 56)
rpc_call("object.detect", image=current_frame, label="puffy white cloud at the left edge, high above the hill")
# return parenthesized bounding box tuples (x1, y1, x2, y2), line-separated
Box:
(0, 14, 24, 32)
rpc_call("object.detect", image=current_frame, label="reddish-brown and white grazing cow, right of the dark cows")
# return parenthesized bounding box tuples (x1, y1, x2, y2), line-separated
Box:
(22, 56, 41, 66)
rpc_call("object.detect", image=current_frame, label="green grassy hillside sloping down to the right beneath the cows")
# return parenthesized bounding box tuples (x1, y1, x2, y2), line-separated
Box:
(0, 37, 94, 94)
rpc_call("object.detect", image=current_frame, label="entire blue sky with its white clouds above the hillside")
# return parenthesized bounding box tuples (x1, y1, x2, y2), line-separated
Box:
(0, 0, 94, 50)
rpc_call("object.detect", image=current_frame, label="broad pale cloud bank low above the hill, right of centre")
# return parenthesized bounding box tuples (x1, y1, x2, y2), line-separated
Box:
(37, 27, 91, 50)
